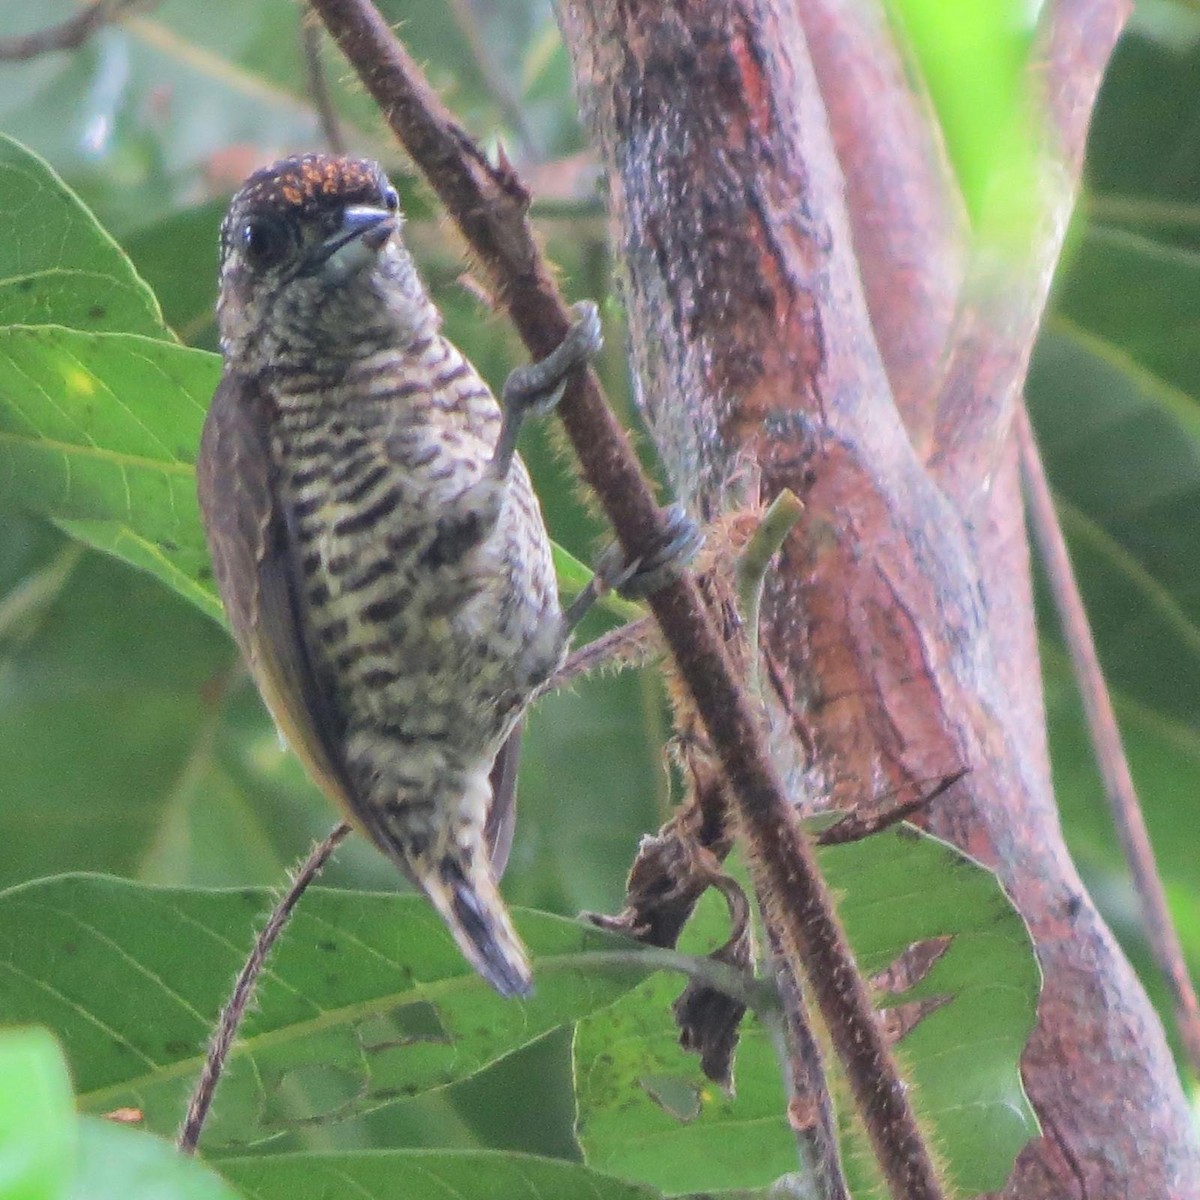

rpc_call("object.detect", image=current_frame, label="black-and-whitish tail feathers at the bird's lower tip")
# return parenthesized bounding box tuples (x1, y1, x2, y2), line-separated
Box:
(420, 857, 533, 996)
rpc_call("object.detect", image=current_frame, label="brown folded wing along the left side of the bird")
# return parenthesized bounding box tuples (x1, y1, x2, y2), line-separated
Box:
(197, 373, 350, 816)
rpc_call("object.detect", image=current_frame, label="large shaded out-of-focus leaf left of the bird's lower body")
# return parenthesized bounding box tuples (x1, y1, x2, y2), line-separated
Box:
(0, 517, 350, 887)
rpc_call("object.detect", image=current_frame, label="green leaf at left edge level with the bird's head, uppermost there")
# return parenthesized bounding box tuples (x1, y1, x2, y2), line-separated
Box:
(0, 134, 169, 337)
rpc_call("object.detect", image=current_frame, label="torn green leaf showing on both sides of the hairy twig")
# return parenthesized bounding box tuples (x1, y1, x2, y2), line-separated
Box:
(575, 827, 1039, 1195)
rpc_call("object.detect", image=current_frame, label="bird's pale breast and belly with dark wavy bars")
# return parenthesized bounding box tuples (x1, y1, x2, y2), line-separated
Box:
(274, 336, 564, 767)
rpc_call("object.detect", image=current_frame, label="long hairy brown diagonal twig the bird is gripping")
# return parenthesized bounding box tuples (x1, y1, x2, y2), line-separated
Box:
(313, 0, 943, 1200)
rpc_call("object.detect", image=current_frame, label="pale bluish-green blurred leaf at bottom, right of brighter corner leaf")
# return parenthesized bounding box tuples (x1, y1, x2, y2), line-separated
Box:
(66, 1117, 238, 1200)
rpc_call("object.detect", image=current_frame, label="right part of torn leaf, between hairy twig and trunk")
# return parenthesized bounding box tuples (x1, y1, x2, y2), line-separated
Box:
(820, 826, 1042, 1195)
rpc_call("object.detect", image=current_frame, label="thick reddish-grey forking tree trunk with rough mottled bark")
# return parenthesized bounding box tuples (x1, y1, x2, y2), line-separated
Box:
(560, 0, 1200, 1200)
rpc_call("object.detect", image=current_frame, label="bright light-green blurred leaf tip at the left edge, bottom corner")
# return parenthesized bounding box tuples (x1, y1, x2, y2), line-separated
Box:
(0, 1028, 76, 1200)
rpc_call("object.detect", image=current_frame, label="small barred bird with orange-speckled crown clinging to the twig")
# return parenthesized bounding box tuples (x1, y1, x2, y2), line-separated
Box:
(197, 154, 609, 996)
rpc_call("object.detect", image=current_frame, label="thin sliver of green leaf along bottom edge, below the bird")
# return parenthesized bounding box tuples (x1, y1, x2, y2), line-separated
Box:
(216, 1150, 654, 1200)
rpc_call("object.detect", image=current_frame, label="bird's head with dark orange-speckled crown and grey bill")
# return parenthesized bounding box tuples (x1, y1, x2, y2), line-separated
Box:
(217, 154, 437, 371)
